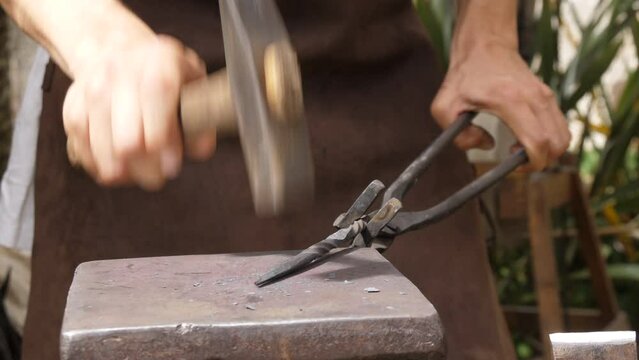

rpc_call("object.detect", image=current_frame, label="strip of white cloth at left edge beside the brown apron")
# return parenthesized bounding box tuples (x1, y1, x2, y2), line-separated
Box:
(0, 48, 49, 251)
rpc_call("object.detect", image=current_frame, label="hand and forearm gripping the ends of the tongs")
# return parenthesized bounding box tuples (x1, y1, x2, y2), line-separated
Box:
(431, 0, 570, 170)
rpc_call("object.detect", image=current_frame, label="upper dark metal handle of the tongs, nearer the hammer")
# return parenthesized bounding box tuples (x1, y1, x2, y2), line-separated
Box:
(383, 112, 477, 203)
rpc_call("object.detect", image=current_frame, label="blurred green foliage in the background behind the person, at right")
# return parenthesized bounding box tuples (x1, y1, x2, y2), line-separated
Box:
(414, 0, 639, 359)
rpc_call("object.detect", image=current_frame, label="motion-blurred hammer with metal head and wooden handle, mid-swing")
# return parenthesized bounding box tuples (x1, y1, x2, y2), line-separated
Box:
(180, 0, 314, 216)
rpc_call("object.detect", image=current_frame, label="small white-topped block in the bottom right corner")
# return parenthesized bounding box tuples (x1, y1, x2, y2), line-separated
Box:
(550, 331, 638, 360)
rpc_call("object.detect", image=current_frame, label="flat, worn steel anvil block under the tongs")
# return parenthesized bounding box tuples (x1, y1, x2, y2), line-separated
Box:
(62, 249, 445, 360)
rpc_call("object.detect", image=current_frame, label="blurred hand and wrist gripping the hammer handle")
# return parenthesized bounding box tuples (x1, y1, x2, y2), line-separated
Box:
(54, 0, 215, 190)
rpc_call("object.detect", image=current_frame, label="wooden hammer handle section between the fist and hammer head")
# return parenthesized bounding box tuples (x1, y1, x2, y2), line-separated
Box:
(180, 69, 237, 141)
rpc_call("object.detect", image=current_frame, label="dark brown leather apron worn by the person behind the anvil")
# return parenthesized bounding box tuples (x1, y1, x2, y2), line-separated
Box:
(24, 0, 514, 360)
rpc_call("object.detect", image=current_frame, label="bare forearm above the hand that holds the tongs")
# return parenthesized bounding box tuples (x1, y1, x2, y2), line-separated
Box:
(451, 0, 518, 61)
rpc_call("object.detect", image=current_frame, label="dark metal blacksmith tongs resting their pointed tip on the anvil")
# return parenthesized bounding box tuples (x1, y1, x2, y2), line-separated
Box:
(255, 113, 528, 286)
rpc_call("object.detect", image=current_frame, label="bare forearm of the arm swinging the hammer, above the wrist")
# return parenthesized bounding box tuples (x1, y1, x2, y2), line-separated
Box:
(0, 0, 153, 78)
